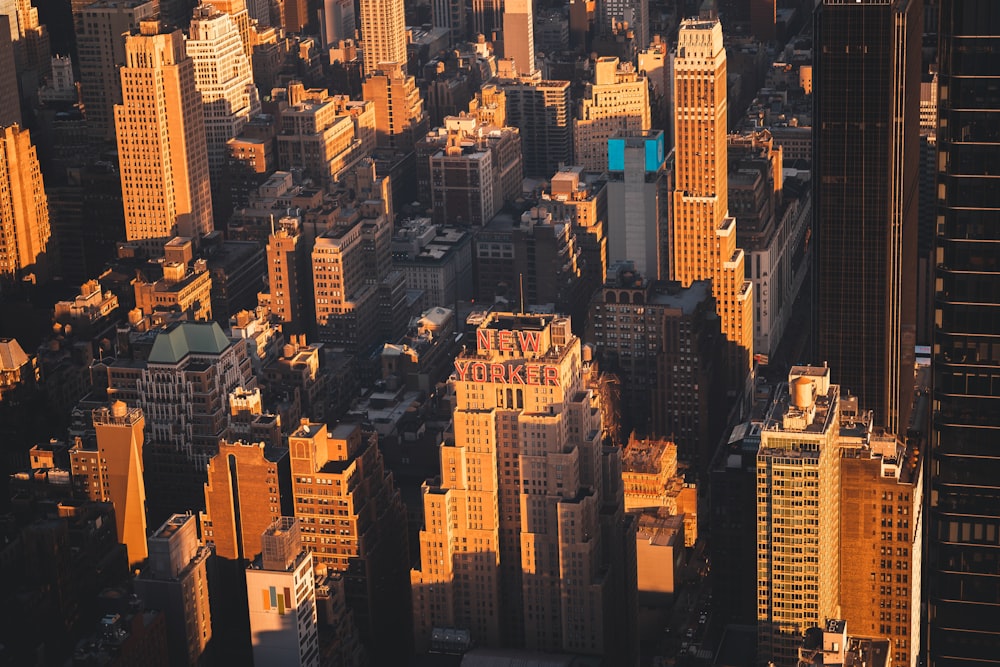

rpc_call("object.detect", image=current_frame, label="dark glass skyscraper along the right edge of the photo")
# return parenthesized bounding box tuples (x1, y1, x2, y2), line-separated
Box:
(924, 0, 1000, 667)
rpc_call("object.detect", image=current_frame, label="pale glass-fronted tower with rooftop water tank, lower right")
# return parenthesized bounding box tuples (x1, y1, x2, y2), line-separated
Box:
(756, 366, 852, 667)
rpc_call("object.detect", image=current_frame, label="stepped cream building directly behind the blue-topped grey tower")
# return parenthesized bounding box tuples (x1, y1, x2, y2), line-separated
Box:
(573, 57, 650, 173)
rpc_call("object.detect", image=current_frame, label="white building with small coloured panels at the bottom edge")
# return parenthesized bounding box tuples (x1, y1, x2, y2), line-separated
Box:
(246, 516, 321, 667)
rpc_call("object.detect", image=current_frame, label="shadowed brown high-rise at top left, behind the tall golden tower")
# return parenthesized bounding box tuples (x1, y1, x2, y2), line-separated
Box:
(73, 0, 157, 141)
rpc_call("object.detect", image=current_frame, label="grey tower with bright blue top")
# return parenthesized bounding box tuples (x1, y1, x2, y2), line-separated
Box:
(607, 130, 668, 280)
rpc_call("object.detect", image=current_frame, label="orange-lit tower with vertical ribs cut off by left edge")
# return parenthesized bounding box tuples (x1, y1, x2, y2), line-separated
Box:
(0, 125, 51, 280)
